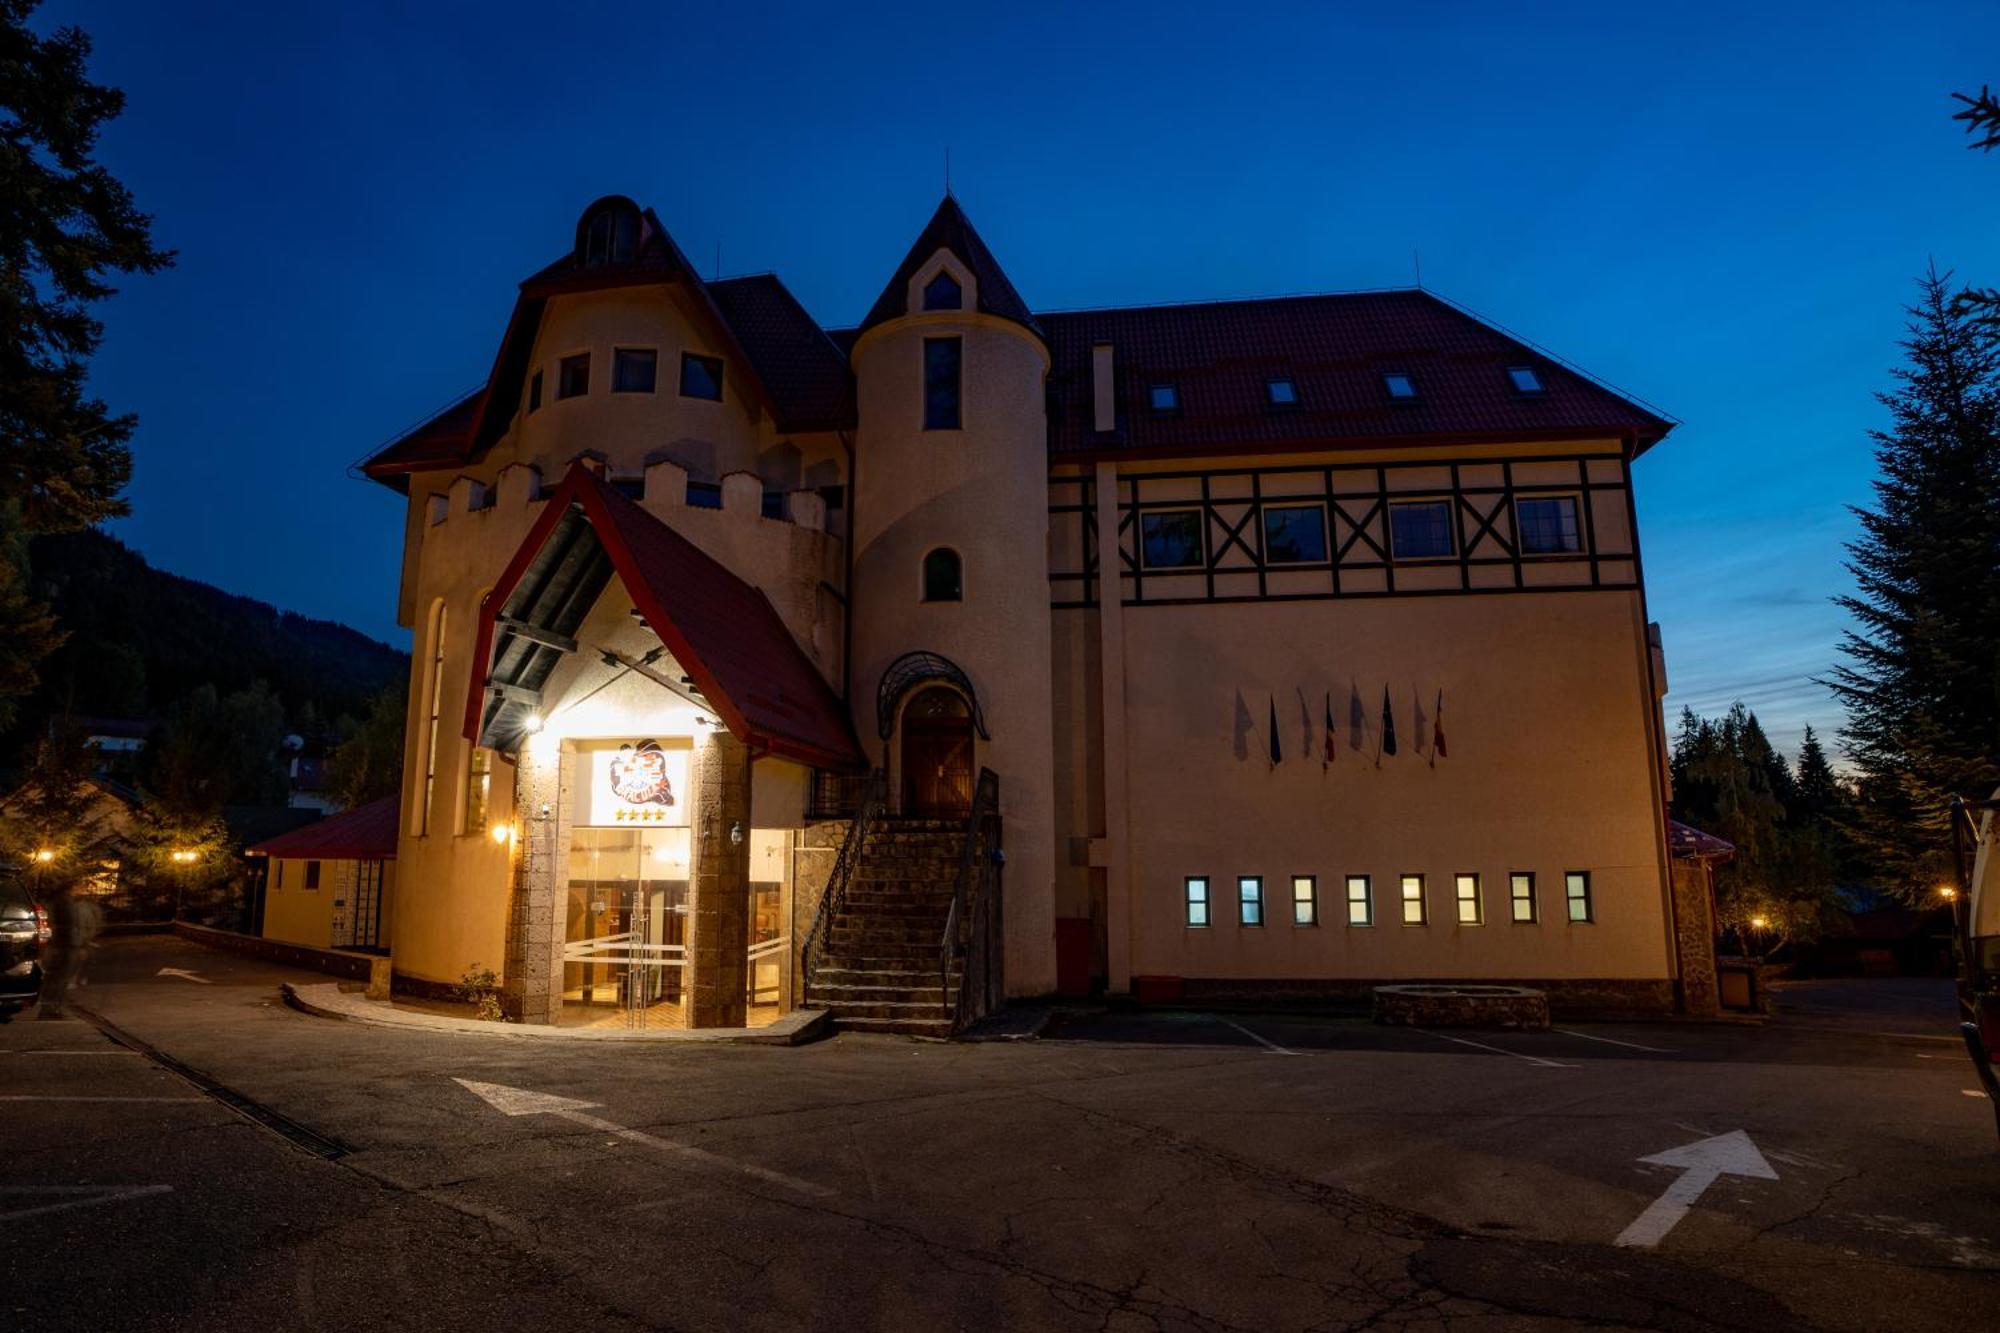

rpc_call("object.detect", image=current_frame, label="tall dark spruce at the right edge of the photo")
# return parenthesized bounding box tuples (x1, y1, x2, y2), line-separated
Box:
(1828, 268, 2000, 901)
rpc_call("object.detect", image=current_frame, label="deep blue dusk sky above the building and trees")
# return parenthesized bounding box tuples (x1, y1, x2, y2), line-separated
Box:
(34, 0, 2000, 749)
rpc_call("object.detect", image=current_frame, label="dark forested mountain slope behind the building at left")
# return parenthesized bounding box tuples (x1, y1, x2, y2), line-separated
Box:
(0, 528, 410, 763)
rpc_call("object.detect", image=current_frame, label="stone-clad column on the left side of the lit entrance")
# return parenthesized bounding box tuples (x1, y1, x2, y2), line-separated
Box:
(500, 737, 566, 1023)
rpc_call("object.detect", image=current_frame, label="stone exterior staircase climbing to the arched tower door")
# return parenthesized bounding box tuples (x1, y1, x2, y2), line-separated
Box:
(806, 817, 966, 1037)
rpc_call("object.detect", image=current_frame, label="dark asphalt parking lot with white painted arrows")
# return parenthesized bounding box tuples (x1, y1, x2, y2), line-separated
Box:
(0, 937, 2000, 1329)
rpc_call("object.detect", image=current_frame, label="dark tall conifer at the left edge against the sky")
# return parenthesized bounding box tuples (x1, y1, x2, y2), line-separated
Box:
(0, 0, 172, 723)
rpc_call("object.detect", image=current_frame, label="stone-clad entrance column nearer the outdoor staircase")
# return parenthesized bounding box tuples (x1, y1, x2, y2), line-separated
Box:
(688, 727, 750, 1027)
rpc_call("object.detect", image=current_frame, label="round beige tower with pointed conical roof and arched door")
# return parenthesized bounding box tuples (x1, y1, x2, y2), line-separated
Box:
(850, 196, 1056, 995)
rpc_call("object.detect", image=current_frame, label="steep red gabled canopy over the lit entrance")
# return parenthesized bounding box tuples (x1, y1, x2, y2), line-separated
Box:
(464, 462, 862, 769)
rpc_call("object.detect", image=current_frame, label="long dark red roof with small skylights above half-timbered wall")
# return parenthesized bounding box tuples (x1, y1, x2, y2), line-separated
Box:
(1042, 290, 1672, 458)
